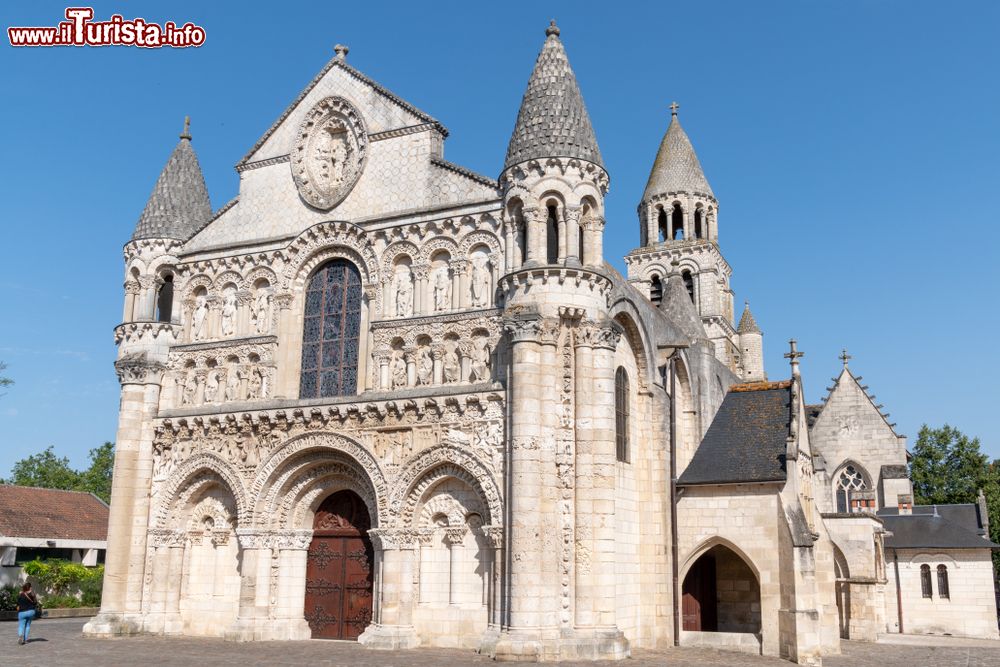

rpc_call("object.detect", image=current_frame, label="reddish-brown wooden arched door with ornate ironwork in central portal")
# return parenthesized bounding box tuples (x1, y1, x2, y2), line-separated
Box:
(305, 491, 374, 639)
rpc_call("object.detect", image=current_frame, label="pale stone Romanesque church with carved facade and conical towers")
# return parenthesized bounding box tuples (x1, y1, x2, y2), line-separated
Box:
(85, 22, 997, 664)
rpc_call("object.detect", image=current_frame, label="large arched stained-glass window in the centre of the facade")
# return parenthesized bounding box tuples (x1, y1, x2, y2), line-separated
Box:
(299, 259, 361, 398)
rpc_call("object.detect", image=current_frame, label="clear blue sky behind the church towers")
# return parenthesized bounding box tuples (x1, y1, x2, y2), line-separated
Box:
(0, 0, 1000, 475)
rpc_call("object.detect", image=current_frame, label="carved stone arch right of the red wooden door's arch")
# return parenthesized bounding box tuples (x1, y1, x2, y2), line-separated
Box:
(389, 444, 503, 526)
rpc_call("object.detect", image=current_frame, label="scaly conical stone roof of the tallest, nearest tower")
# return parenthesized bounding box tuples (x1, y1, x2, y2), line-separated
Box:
(504, 21, 604, 168)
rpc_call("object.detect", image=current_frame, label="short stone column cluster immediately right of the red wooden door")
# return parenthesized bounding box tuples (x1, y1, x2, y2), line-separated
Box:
(358, 528, 420, 650)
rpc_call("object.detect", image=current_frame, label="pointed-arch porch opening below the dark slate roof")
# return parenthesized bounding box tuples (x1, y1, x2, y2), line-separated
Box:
(681, 544, 761, 634)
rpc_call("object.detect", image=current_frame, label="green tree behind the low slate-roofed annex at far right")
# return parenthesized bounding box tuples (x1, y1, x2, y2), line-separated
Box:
(910, 424, 988, 504)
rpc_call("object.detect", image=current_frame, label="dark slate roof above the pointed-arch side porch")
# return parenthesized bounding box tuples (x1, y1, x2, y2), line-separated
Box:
(677, 380, 792, 486)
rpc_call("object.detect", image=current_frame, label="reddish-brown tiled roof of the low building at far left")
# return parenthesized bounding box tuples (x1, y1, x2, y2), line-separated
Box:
(0, 484, 108, 541)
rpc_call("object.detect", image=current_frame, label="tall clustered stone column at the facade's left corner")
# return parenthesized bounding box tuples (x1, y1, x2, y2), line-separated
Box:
(84, 352, 164, 637)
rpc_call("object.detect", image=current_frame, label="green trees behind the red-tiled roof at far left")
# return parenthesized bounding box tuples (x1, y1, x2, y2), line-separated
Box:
(0, 442, 115, 503)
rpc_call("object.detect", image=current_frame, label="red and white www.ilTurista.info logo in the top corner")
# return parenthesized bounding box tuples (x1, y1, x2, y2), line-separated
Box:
(7, 7, 205, 49)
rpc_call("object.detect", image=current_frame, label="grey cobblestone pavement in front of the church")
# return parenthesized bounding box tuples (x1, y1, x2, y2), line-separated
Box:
(11, 619, 1000, 667)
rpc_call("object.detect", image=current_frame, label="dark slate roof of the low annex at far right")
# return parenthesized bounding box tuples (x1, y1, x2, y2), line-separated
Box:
(878, 504, 1000, 549)
